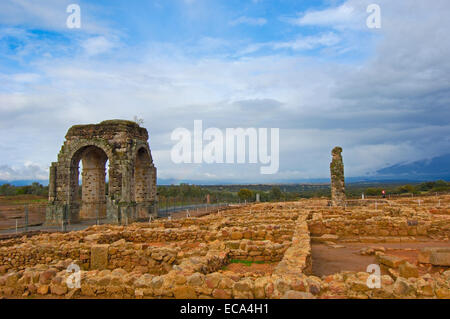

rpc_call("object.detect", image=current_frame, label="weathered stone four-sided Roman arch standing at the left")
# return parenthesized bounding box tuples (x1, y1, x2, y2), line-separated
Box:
(46, 120, 156, 225)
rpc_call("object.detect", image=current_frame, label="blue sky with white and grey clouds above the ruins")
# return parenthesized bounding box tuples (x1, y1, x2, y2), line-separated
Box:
(0, 0, 450, 183)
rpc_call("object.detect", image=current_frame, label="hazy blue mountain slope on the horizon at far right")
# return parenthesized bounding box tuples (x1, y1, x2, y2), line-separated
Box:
(376, 154, 450, 181)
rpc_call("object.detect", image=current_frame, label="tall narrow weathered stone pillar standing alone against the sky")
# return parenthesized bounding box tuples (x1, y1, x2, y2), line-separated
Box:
(330, 146, 346, 206)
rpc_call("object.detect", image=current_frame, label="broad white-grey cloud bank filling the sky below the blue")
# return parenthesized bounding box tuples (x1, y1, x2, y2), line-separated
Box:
(0, 0, 450, 182)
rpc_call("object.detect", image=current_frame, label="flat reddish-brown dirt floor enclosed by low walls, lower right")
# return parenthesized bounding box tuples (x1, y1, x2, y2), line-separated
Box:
(311, 241, 450, 277)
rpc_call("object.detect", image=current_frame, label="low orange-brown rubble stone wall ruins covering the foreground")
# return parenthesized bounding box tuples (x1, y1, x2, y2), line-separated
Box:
(0, 201, 450, 299)
